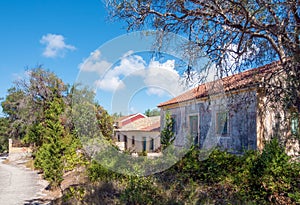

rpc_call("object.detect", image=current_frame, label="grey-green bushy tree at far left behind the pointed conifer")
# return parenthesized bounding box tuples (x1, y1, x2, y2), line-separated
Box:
(1, 67, 67, 143)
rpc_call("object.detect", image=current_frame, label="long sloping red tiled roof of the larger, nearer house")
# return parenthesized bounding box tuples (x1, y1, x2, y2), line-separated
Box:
(158, 61, 280, 107)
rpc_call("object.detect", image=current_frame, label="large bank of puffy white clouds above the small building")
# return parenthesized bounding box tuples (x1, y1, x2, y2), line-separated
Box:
(79, 50, 192, 97)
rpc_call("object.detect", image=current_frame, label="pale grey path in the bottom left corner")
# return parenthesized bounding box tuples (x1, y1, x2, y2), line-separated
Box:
(0, 160, 45, 205)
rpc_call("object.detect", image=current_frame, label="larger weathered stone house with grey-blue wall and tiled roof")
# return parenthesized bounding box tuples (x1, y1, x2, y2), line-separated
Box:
(158, 62, 299, 155)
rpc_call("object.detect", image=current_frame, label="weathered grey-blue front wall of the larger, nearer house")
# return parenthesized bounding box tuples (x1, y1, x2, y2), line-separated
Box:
(161, 90, 257, 153)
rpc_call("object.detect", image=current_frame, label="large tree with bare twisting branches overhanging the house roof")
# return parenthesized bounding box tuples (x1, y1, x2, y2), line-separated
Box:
(107, 0, 300, 112)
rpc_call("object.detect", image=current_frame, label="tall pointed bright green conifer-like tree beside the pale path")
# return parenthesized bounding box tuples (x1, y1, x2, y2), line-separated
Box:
(35, 98, 86, 186)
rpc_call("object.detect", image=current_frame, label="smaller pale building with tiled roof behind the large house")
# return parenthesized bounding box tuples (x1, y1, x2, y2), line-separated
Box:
(114, 114, 160, 152)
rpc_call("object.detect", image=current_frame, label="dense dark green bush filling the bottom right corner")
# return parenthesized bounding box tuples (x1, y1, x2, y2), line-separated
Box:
(239, 139, 300, 201)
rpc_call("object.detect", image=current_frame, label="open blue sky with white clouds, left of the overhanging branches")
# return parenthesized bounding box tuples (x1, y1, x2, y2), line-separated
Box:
(0, 0, 202, 114)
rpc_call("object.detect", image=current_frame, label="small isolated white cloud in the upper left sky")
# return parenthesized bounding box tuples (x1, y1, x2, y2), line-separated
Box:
(40, 33, 76, 58)
